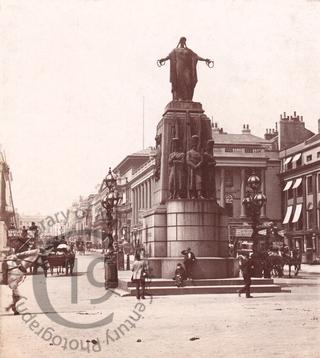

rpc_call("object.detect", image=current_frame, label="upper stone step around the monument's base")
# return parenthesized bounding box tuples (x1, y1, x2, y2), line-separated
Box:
(118, 278, 274, 290)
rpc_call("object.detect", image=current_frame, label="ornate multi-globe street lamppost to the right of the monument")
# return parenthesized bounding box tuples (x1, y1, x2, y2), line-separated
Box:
(242, 173, 267, 254)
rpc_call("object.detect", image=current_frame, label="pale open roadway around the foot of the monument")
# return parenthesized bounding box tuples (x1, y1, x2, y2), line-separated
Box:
(0, 253, 320, 358)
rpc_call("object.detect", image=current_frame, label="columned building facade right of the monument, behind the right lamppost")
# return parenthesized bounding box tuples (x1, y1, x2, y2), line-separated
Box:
(212, 123, 282, 249)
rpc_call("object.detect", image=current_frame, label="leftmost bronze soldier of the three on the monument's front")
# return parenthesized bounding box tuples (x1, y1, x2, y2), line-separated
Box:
(168, 138, 185, 199)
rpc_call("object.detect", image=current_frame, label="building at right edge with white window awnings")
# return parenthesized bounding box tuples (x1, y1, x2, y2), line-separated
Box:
(279, 113, 320, 263)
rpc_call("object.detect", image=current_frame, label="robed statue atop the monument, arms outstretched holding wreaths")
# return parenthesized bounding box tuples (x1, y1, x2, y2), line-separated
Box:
(157, 37, 213, 101)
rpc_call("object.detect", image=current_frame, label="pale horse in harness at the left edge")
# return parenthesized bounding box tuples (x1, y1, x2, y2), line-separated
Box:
(4, 249, 48, 315)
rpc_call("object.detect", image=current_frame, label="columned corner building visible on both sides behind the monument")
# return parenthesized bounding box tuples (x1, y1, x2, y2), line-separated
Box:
(107, 124, 282, 253)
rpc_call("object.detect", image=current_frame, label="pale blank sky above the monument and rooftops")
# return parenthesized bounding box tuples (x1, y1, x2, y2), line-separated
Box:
(0, 0, 320, 214)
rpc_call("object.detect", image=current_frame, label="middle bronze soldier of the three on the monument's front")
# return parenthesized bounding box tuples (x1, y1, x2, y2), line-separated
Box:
(186, 135, 204, 199)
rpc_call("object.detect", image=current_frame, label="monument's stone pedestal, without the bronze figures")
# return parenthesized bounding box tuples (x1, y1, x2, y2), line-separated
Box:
(143, 101, 238, 278)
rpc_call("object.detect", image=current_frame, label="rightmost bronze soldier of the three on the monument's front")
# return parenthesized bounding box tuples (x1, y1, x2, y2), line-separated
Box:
(202, 139, 216, 200)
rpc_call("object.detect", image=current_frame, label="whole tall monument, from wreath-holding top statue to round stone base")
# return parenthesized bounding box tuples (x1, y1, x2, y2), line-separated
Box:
(143, 37, 235, 278)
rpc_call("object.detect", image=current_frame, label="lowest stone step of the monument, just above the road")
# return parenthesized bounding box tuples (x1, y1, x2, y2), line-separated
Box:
(122, 284, 288, 296)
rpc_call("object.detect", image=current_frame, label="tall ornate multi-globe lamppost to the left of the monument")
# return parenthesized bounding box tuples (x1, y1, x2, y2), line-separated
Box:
(101, 168, 122, 288)
